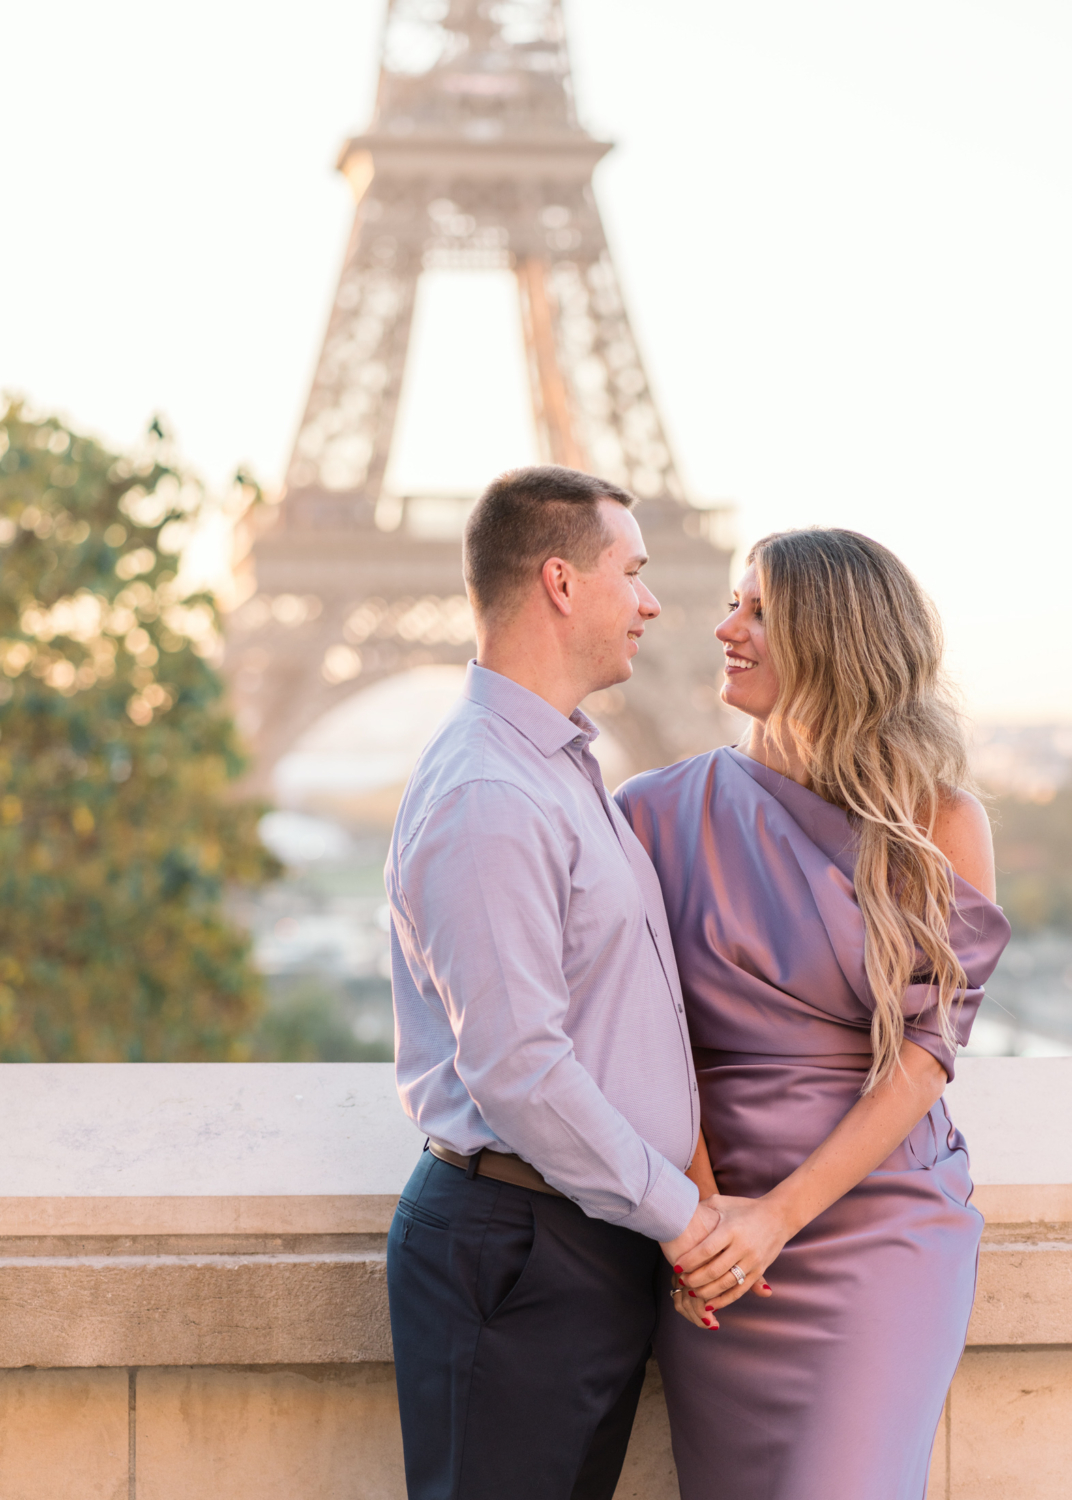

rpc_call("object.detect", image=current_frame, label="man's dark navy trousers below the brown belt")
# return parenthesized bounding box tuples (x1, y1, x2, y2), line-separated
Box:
(387, 1151, 661, 1500)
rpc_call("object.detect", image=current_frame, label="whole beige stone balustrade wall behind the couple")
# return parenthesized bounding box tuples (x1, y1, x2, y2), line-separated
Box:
(0, 1058, 1072, 1500)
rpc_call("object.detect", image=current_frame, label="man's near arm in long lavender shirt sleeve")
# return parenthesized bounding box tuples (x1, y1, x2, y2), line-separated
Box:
(390, 782, 697, 1241)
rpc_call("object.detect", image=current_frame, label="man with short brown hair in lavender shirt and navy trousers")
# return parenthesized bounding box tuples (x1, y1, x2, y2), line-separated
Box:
(387, 468, 718, 1500)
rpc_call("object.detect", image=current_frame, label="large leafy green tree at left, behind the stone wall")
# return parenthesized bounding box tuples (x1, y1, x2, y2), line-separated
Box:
(0, 404, 277, 1062)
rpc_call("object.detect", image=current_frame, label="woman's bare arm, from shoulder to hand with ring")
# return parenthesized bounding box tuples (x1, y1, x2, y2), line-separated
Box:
(675, 792, 994, 1311)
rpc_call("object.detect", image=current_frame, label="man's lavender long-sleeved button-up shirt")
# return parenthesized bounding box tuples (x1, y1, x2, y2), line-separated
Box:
(387, 662, 699, 1241)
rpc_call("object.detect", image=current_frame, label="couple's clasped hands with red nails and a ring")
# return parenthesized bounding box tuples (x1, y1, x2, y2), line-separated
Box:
(663, 1193, 790, 1328)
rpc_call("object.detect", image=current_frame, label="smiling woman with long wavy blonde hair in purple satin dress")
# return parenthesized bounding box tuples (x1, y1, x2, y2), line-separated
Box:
(618, 530, 1009, 1500)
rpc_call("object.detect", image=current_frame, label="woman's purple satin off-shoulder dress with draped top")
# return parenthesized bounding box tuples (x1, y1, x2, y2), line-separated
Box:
(618, 749, 1009, 1500)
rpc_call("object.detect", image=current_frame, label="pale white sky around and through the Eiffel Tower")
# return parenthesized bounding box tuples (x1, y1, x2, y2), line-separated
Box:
(0, 0, 1072, 723)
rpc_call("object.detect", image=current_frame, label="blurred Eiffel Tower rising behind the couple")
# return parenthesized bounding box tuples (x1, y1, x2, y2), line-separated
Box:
(226, 0, 729, 789)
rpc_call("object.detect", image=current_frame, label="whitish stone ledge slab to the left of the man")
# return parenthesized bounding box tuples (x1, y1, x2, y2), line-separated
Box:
(0, 1062, 424, 1199)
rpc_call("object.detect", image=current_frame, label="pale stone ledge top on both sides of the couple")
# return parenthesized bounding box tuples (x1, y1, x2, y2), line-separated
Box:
(0, 1058, 1072, 1206)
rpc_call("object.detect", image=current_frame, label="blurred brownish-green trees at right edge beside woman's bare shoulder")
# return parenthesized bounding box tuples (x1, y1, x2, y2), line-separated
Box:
(991, 785, 1072, 933)
